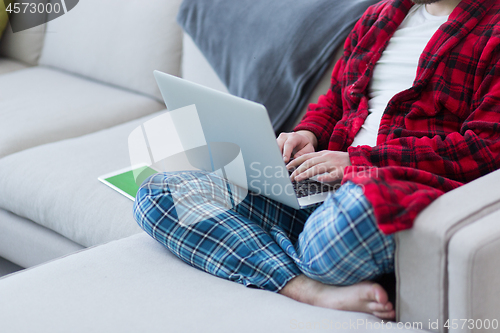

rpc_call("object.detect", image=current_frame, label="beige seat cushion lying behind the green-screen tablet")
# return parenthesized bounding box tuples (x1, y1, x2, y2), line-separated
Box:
(0, 114, 171, 247)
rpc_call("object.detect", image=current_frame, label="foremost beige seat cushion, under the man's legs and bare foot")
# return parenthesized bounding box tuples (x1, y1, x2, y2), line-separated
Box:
(0, 233, 416, 333)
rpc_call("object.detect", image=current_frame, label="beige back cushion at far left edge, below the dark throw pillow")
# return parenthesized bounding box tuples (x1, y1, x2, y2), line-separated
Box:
(0, 0, 47, 66)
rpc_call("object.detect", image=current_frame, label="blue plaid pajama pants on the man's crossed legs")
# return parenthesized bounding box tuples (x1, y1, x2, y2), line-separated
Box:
(134, 171, 395, 291)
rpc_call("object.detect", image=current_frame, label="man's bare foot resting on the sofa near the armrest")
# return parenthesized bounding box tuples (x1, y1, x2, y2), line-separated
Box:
(279, 275, 396, 319)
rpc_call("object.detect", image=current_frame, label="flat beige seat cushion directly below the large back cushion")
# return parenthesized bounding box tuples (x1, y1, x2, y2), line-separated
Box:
(0, 67, 164, 157)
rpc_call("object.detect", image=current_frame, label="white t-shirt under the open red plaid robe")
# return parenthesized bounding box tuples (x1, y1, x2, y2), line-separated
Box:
(352, 5, 448, 147)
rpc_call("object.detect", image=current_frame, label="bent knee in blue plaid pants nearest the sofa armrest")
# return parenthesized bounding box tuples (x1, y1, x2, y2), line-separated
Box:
(297, 183, 394, 285)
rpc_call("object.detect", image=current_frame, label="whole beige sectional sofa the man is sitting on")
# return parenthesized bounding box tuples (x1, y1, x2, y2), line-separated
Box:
(0, 0, 500, 332)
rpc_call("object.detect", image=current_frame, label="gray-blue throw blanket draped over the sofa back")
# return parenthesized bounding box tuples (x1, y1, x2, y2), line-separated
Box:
(177, 0, 378, 132)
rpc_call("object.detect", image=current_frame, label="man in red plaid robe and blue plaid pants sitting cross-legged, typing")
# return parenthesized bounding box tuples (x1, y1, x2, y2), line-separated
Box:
(135, 0, 500, 318)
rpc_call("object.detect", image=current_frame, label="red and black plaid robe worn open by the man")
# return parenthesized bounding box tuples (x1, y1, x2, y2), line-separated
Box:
(295, 0, 500, 234)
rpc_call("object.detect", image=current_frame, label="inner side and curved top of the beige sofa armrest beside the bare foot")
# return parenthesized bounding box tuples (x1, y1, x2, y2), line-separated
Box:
(395, 170, 500, 332)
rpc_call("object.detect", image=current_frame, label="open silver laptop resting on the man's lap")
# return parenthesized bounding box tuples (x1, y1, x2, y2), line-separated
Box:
(154, 71, 339, 209)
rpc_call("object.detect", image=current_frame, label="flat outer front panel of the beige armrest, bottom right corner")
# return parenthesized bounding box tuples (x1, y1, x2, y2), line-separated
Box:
(448, 211, 500, 333)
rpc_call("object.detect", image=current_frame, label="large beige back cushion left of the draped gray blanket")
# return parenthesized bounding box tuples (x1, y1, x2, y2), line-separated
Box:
(40, 0, 182, 100)
